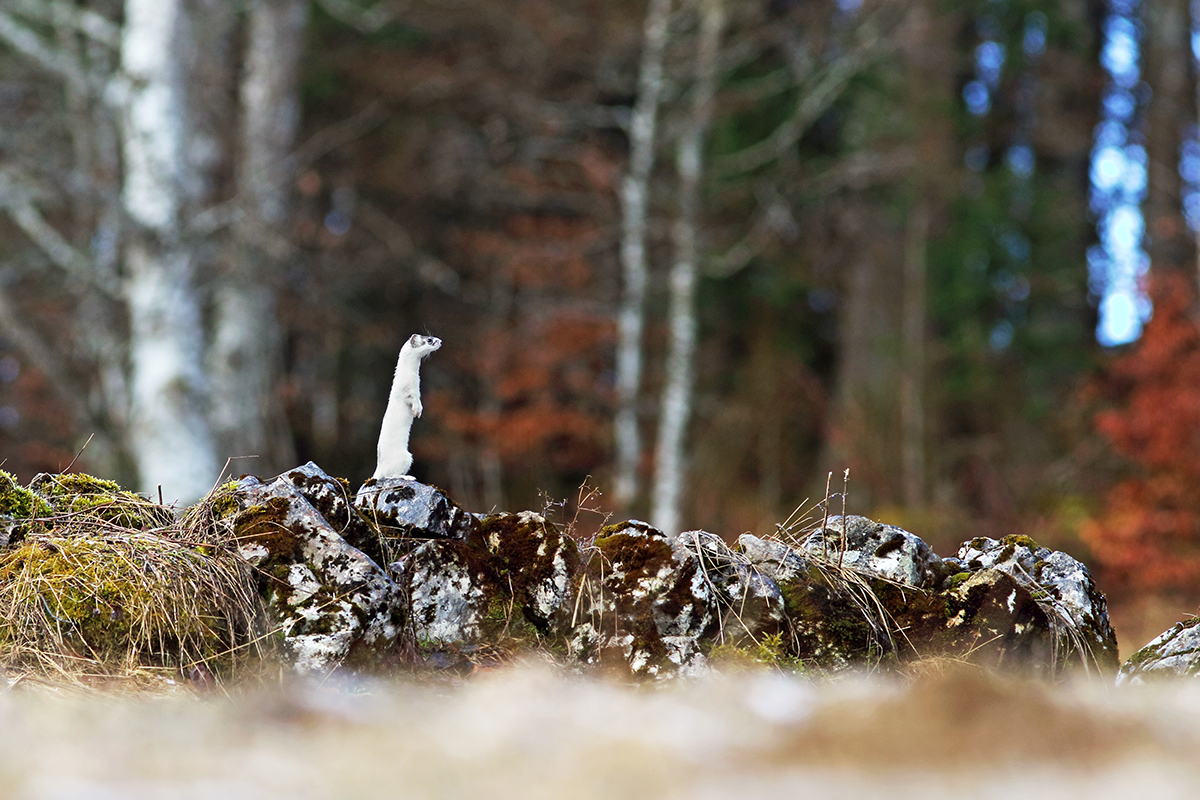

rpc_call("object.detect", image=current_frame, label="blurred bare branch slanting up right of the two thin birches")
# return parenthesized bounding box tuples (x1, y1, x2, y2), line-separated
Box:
(713, 7, 895, 178)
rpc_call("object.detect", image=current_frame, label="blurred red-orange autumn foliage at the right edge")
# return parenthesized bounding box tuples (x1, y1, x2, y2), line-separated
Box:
(1081, 273, 1200, 590)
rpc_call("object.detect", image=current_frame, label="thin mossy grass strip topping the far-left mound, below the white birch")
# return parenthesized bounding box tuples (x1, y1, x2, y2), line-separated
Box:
(30, 473, 175, 530)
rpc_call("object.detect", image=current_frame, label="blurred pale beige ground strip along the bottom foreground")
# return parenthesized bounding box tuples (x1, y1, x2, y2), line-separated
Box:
(0, 664, 1200, 800)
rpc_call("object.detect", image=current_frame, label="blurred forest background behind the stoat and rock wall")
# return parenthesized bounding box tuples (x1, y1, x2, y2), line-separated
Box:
(0, 0, 1200, 652)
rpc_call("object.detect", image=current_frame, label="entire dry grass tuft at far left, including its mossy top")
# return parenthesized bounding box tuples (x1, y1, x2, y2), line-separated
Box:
(0, 474, 266, 686)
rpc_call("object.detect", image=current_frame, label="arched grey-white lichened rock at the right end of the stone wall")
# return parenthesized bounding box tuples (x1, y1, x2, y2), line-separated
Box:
(956, 536, 1120, 672)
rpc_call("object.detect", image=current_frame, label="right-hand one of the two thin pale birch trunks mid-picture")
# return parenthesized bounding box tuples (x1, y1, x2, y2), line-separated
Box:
(650, 0, 725, 536)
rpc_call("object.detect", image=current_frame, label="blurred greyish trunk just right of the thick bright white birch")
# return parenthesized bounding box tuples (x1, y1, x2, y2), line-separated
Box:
(209, 0, 308, 474)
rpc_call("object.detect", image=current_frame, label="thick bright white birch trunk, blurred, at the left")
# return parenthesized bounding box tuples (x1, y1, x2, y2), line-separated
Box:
(121, 0, 220, 503)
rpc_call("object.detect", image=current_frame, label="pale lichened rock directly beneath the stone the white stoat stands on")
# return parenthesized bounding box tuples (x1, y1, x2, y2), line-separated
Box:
(390, 539, 492, 648)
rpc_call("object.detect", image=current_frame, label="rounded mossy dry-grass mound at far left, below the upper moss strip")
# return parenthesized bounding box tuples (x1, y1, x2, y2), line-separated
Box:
(0, 534, 263, 672)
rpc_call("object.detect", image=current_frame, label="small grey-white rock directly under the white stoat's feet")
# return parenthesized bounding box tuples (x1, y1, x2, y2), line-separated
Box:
(354, 477, 479, 542)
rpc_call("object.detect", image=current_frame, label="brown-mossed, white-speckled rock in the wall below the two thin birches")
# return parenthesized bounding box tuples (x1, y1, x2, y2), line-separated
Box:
(568, 521, 719, 678)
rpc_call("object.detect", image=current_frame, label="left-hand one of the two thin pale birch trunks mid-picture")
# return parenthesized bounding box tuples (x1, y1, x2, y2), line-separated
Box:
(613, 0, 672, 507)
